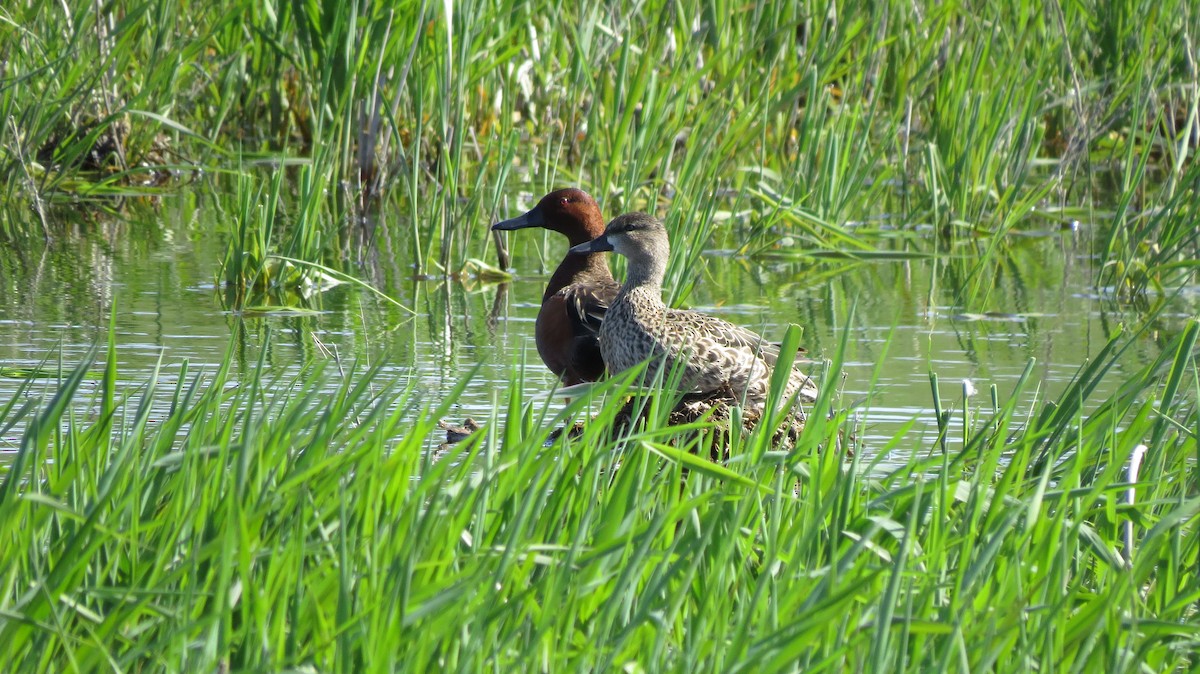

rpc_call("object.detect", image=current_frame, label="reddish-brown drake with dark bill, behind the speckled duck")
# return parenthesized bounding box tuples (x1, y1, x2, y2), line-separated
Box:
(492, 188, 620, 386)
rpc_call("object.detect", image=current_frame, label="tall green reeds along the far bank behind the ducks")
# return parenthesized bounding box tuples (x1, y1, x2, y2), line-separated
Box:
(0, 0, 1200, 299)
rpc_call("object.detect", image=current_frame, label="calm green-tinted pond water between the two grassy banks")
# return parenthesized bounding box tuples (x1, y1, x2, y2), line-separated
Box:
(0, 196, 1192, 465)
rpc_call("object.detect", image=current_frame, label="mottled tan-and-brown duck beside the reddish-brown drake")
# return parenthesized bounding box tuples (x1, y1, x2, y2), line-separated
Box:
(569, 213, 817, 409)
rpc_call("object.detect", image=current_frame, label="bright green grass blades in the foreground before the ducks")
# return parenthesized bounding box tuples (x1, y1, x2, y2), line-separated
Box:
(0, 316, 1200, 672)
